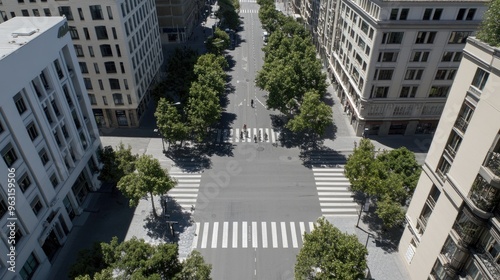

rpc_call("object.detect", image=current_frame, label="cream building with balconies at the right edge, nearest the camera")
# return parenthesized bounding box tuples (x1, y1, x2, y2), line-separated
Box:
(399, 38, 500, 280)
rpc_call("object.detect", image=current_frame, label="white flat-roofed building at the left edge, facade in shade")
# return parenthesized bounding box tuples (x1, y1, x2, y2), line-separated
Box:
(0, 17, 101, 280)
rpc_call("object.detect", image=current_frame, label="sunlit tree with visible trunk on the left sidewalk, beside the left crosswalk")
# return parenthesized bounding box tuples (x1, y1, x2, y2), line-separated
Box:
(118, 155, 176, 217)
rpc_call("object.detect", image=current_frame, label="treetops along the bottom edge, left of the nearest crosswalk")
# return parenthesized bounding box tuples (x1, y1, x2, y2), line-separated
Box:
(68, 237, 212, 280)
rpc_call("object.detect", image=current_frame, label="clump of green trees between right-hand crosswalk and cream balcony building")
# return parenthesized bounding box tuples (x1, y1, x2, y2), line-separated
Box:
(345, 139, 421, 228)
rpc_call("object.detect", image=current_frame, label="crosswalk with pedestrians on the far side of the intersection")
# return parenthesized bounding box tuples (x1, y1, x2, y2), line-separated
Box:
(215, 128, 280, 143)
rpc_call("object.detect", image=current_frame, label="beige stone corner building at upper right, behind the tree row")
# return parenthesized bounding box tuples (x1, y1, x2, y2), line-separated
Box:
(314, 0, 488, 136)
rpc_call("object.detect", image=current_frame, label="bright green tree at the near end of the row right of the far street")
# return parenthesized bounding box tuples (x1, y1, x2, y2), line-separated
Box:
(287, 91, 333, 136)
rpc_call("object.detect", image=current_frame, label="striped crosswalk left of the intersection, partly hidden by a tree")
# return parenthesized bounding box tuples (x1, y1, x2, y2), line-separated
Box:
(167, 170, 201, 211)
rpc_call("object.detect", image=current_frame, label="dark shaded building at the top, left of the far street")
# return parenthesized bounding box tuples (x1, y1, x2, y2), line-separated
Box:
(156, 0, 205, 44)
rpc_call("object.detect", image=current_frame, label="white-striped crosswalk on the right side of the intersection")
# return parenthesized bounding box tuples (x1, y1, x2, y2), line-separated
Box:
(313, 167, 358, 216)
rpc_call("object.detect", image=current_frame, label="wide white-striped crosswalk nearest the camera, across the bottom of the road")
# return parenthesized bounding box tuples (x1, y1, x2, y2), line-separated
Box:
(192, 221, 314, 249)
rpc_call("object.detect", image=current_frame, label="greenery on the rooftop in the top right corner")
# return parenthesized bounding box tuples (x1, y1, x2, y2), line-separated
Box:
(476, 0, 500, 47)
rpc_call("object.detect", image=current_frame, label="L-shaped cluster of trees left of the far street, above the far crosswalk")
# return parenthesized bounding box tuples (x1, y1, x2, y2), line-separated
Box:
(155, 53, 228, 145)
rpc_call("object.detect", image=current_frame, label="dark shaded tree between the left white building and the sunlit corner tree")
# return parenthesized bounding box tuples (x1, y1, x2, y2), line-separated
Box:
(97, 142, 138, 183)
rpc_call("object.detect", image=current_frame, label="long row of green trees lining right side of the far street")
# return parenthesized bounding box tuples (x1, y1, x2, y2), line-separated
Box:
(255, 0, 333, 135)
